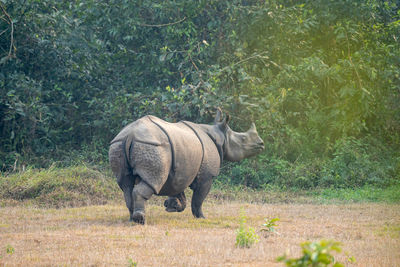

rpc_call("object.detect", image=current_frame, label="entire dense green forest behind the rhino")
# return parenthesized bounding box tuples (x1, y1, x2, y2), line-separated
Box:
(0, 0, 400, 193)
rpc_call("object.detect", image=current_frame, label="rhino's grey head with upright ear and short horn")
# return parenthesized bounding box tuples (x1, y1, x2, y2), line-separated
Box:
(214, 109, 264, 161)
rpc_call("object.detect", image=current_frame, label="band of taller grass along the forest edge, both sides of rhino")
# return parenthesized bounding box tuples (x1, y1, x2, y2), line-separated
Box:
(0, 165, 400, 209)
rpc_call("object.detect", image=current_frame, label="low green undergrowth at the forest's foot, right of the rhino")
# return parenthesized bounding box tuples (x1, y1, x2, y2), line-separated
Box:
(217, 137, 400, 190)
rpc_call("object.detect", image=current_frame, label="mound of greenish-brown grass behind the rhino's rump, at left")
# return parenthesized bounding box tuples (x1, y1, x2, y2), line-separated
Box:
(0, 166, 120, 207)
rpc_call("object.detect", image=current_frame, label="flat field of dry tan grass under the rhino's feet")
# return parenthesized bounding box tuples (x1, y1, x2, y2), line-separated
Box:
(0, 201, 400, 267)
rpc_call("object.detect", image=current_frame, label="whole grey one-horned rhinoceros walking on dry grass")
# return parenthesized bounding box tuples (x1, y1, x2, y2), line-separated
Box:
(109, 109, 264, 224)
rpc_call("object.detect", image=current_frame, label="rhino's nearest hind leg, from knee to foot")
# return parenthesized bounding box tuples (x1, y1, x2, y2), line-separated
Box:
(132, 181, 154, 224)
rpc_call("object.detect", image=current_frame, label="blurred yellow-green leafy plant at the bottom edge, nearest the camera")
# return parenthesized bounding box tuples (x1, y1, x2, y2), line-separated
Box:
(277, 240, 346, 267)
